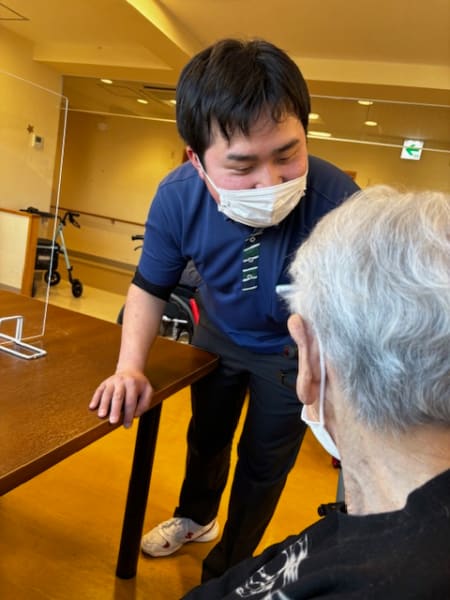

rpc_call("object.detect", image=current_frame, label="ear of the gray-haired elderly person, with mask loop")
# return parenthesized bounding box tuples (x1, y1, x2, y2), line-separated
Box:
(289, 315, 320, 404)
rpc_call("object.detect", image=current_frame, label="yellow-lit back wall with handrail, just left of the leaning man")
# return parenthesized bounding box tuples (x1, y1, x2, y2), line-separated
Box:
(60, 111, 183, 265)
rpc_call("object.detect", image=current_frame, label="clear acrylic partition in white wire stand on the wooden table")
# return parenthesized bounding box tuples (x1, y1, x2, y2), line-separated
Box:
(0, 71, 68, 350)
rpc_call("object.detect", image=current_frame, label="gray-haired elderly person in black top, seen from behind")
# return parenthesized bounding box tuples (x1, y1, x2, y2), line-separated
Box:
(183, 186, 450, 600)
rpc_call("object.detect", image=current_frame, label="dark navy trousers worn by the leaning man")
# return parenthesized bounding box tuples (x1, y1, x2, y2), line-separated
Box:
(175, 314, 306, 581)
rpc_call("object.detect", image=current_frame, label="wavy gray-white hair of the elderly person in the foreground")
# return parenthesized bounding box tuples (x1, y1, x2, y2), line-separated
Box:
(289, 186, 450, 431)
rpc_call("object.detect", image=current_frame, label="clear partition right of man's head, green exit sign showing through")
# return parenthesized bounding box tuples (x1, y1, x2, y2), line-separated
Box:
(308, 95, 450, 192)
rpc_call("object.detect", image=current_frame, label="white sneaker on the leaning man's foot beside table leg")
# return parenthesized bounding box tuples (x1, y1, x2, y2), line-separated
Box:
(141, 517, 219, 556)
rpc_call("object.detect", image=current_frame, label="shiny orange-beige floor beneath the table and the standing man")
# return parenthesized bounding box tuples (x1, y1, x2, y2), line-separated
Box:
(0, 282, 337, 600)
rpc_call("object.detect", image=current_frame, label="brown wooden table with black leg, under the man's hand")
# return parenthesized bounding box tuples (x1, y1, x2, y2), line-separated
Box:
(0, 291, 217, 579)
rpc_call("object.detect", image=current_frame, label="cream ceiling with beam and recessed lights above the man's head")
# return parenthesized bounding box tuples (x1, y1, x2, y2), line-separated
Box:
(0, 0, 450, 150)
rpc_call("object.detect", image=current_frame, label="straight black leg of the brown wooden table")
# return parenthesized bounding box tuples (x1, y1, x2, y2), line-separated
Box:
(116, 404, 162, 579)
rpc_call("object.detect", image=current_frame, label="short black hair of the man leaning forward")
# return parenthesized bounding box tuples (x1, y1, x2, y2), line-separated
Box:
(176, 39, 310, 159)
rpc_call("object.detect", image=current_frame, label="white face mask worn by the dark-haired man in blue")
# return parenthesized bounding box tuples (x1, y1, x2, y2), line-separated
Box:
(198, 160, 308, 227)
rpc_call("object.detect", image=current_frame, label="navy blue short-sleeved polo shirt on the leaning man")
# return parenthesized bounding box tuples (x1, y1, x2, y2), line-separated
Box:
(138, 156, 358, 354)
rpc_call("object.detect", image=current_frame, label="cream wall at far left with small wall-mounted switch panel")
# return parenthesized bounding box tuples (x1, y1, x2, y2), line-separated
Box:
(0, 27, 62, 210)
